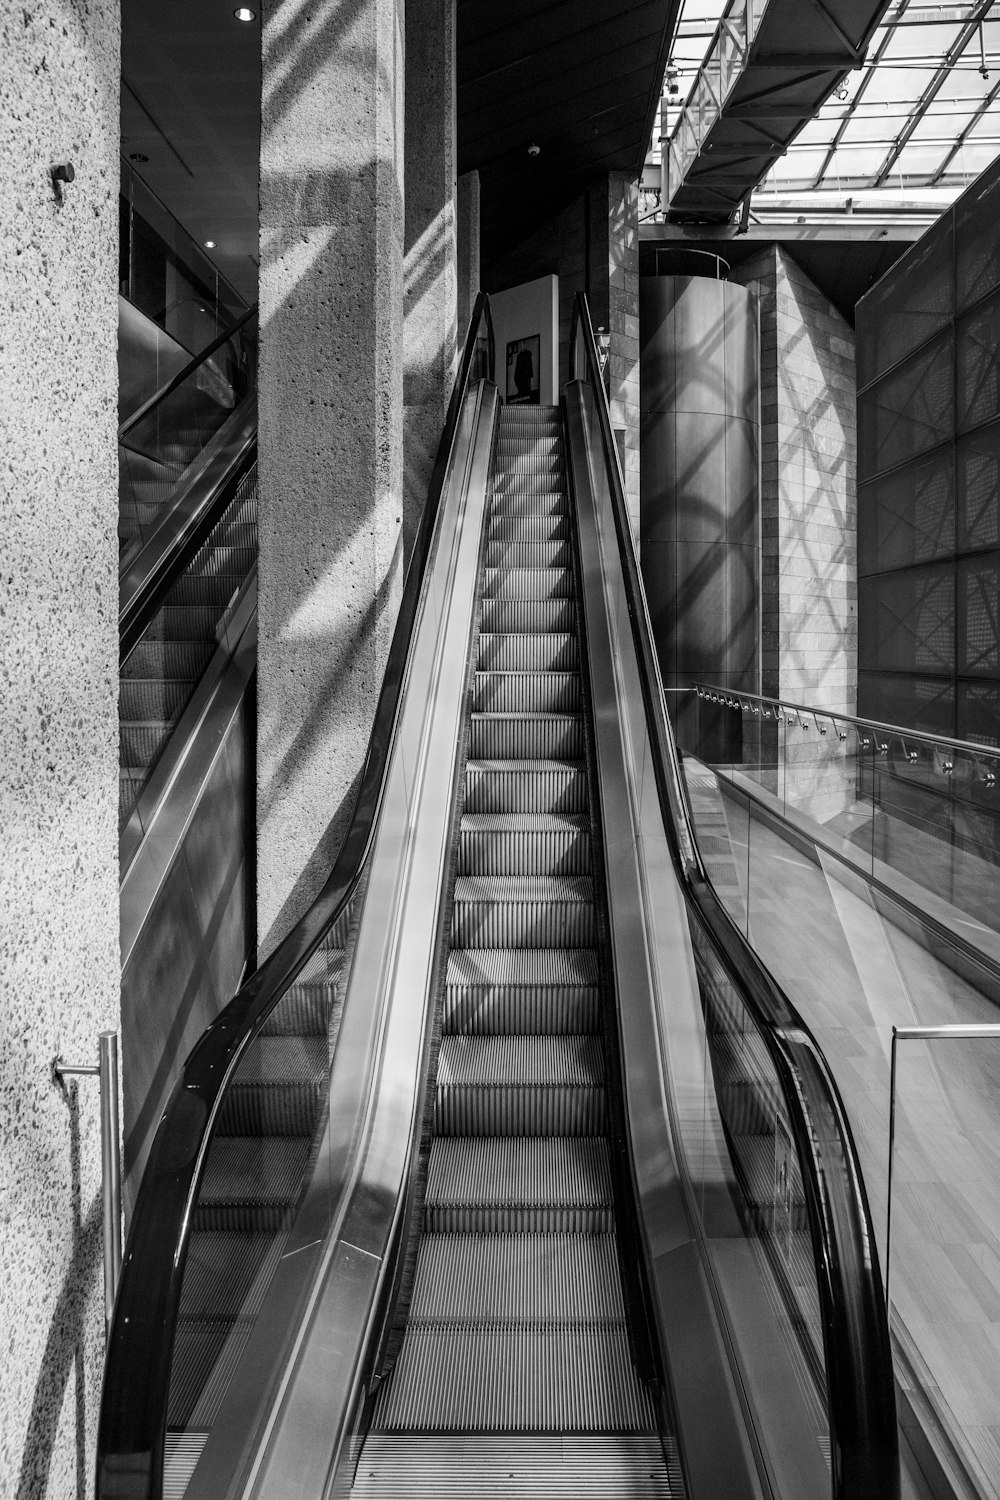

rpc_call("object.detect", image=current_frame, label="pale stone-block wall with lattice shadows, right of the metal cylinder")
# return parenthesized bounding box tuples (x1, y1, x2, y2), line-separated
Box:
(732, 246, 858, 713)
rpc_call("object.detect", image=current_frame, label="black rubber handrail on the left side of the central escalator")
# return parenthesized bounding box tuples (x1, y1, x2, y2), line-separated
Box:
(96, 293, 495, 1500)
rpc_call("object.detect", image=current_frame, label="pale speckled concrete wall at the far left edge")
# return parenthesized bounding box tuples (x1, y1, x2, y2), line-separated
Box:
(0, 0, 118, 1500)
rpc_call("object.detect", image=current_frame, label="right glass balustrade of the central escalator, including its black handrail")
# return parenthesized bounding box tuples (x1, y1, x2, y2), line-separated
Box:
(571, 297, 900, 1500)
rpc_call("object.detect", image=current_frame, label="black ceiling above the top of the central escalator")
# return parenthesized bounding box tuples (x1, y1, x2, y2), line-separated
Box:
(457, 0, 679, 263)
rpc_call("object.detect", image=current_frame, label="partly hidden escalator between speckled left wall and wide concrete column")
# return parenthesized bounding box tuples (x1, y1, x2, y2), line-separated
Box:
(118, 309, 256, 1209)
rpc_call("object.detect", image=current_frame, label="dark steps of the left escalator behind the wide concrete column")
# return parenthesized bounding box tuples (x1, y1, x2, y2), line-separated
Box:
(118, 465, 256, 824)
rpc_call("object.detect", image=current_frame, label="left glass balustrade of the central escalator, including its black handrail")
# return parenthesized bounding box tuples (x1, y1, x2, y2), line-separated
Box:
(96, 294, 495, 1500)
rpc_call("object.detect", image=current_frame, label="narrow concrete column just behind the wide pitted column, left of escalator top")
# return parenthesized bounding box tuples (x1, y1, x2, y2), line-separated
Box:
(403, 0, 457, 555)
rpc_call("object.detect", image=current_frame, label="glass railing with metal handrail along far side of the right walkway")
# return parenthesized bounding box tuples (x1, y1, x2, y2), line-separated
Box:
(685, 686, 1000, 959)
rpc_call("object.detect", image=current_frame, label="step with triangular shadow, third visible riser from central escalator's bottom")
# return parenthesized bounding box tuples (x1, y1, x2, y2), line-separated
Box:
(441, 948, 600, 1035)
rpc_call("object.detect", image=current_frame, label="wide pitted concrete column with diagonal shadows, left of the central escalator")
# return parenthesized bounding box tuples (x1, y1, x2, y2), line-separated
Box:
(258, 0, 403, 954)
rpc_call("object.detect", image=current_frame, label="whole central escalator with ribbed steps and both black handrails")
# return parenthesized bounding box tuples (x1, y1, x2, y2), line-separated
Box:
(96, 297, 898, 1500)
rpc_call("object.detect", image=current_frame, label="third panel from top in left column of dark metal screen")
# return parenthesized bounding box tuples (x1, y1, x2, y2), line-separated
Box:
(858, 449, 955, 576)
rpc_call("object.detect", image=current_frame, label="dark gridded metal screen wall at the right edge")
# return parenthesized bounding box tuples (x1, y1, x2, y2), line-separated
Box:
(856, 149, 1000, 744)
